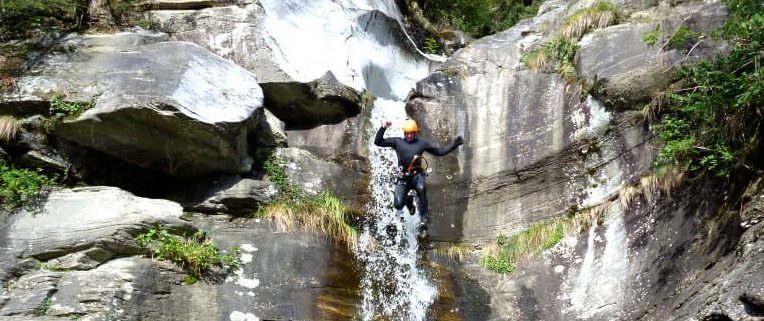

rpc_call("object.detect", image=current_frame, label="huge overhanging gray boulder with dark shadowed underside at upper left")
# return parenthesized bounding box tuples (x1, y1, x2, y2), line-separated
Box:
(6, 33, 263, 176)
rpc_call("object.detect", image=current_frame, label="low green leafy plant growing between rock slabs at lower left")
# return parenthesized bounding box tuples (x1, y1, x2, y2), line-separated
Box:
(135, 226, 241, 280)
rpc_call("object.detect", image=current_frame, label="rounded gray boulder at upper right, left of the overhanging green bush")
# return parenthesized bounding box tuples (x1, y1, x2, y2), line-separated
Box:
(576, 2, 727, 108)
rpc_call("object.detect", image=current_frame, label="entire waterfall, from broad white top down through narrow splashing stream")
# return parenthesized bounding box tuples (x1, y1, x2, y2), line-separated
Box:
(260, 0, 437, 321)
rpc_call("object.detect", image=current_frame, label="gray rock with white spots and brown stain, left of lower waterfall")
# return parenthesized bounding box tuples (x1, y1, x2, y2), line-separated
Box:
(134, 217, 360, 321)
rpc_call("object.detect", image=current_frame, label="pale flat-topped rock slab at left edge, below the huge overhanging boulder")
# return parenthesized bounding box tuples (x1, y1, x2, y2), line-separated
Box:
(0, 187, 185, 260)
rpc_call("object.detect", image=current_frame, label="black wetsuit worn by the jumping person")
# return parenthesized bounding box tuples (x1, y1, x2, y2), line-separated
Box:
(374, 127, 462, 224)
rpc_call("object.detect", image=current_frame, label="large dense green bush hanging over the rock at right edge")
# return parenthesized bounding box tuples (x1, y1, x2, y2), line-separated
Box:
(655, 0, 764, 176)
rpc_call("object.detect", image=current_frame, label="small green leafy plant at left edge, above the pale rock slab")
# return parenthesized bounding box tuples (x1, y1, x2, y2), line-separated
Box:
(0, 159, 54, 210)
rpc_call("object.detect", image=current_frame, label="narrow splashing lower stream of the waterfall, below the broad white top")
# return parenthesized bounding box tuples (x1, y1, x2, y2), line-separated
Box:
(358, 100, 436, 321)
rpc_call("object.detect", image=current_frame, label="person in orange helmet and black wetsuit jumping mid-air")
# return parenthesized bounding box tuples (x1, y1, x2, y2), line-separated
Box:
(374, 119, 464, 232)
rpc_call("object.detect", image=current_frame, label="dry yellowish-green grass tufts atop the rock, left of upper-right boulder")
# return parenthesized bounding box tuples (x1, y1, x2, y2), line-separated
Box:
(520, 1, 618, 81)
